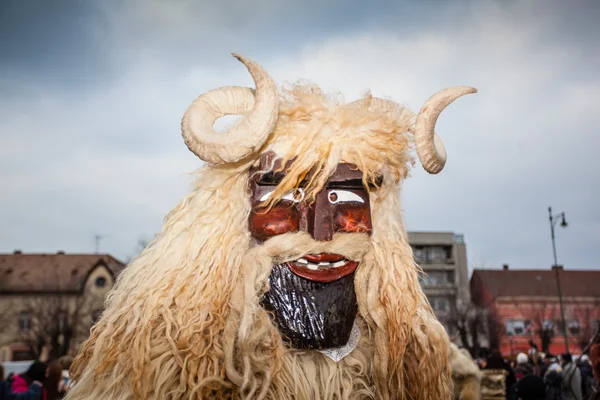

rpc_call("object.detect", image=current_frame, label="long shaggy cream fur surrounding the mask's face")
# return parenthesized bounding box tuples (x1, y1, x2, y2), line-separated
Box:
(67, 84, 452, 400)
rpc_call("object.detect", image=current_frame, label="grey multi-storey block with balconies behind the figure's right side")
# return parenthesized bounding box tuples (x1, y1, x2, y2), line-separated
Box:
(408, 232, 469, 336)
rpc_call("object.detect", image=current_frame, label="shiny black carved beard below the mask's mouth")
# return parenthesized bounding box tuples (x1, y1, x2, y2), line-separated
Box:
(261, 264, 358, 349)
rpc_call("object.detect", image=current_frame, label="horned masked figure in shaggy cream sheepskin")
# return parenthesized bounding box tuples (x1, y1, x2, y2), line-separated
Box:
(68, 56, 475, 400)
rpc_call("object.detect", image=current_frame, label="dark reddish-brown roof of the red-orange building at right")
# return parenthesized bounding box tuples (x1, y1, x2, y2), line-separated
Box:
(471, 267, 600, 297)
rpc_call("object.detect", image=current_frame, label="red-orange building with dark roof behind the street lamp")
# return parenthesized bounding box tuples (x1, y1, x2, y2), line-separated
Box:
(470, 265, 600, 355)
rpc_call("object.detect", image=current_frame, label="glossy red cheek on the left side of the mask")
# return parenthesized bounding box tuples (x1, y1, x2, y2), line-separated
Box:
(249, 206, 300, 240)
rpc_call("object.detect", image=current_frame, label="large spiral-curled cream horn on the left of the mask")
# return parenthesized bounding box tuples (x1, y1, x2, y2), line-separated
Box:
(181, 54, 279, 164)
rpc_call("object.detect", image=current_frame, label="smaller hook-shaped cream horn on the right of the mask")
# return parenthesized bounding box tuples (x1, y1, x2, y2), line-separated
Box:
(413, 86, 477, 174)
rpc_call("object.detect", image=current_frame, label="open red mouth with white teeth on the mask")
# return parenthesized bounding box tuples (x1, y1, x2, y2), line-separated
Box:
(287, 253, 358, 282)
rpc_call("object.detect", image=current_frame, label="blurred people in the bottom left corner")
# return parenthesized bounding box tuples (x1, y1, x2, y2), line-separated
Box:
(0, 357, 71, 400)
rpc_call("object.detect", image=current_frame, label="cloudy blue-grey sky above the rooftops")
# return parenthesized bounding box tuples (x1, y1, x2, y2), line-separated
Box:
(0, 0, 600, 269)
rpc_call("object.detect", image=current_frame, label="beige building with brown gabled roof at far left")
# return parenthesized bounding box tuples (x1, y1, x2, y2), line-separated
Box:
(0, 251, 125, 361)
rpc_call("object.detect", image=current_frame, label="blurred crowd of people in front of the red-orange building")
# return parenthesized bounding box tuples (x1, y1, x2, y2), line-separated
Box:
(474, 345, 600, 400)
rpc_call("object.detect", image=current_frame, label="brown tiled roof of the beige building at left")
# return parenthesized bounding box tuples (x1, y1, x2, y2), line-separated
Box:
(0, 252, 125, 294)
